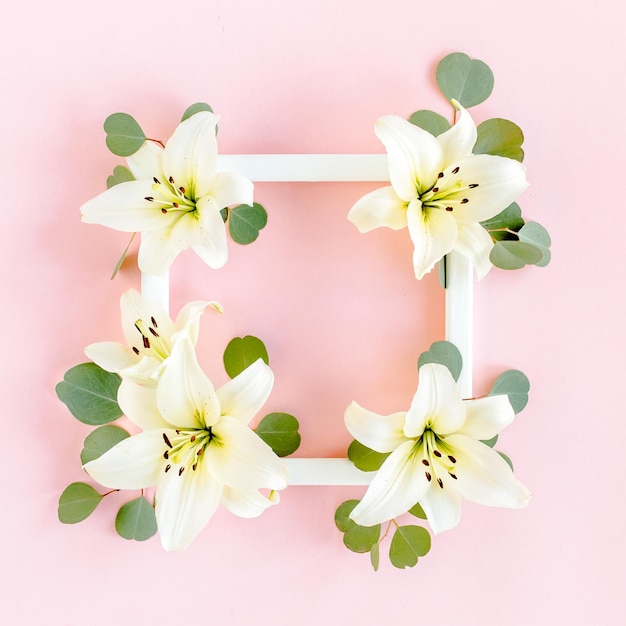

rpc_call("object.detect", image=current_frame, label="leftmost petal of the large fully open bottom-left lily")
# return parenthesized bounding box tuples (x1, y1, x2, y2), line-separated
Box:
(83, 431, 163, 489)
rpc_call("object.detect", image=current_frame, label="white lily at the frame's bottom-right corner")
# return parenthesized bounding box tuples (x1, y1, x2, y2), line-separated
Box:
(345, 363, 530, 533)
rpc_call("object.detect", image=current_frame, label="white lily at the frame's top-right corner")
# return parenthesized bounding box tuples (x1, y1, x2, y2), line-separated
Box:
(348, 102, 528, 279)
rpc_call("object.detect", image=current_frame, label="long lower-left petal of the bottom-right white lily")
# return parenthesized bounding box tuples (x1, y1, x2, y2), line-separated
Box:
(350, 441, 430, 526)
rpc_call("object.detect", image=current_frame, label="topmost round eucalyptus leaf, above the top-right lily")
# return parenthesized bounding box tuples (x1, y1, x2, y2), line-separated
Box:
(436, 52, 493, 108)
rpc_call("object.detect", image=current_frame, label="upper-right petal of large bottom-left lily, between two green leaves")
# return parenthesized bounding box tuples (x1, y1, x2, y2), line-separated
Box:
(215, 359, 274, 425)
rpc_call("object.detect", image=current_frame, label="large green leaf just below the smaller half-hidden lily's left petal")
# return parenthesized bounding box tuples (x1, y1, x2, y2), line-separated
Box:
(56, 363, 122, 426)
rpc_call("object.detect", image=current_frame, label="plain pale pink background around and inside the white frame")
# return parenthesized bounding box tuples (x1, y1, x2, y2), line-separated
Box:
(0, 0, 626, 626)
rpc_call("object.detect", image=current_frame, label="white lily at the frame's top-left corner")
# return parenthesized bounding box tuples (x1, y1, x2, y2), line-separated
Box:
(81, 111, 253, 275)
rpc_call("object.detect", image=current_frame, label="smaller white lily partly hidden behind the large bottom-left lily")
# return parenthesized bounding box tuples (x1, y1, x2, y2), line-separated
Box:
(85, 289, 222, 386)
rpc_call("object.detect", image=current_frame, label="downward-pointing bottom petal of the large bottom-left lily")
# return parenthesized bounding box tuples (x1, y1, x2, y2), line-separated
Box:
(155, 458, 223, 551)
